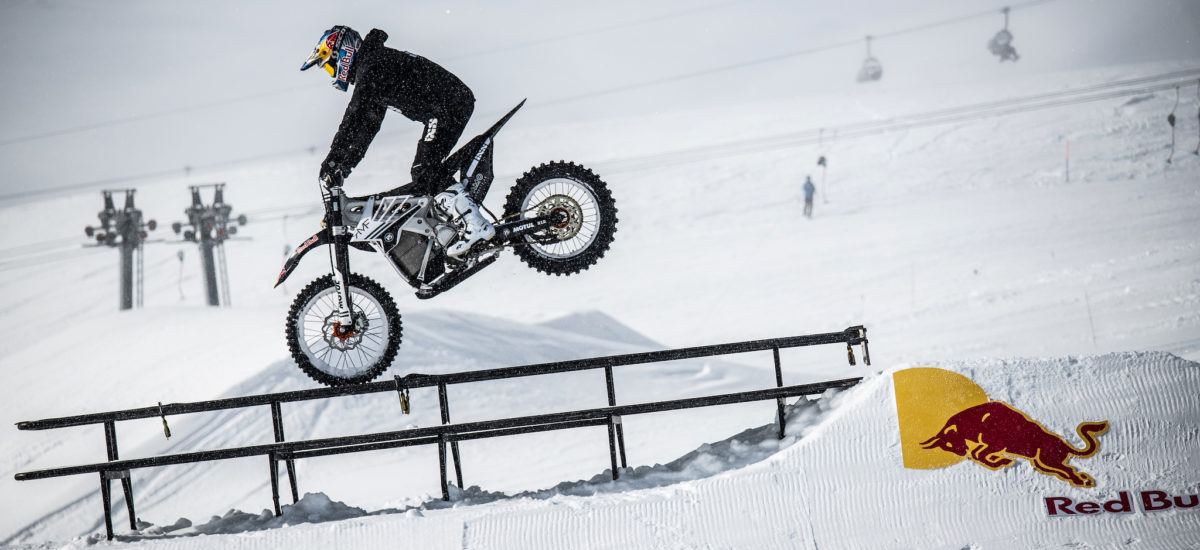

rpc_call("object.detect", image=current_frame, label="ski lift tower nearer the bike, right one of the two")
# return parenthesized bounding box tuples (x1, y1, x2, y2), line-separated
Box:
(170, 184, 246, 306)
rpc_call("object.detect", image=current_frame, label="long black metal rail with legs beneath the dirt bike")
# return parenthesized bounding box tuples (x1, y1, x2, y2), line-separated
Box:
(14, 325, 870, 539)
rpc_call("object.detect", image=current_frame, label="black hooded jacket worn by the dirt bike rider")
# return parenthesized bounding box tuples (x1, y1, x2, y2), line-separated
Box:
(325, 29, 475, 174)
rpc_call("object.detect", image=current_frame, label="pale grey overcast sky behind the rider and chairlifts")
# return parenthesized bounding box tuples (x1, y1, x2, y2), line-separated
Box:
(0, 0, 1200, 202)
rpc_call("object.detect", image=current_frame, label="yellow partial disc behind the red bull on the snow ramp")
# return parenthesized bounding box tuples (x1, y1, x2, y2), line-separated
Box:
(892, 367, 988, 470)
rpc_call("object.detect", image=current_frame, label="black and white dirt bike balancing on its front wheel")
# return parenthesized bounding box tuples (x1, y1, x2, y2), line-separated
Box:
(275, 101, 617, 385)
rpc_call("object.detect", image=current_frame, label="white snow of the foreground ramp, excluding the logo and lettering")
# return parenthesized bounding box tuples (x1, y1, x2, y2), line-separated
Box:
(11, 353, 1200, 549)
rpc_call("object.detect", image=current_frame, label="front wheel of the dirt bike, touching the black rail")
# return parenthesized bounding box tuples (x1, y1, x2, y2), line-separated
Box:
(286, 274, 401, 385)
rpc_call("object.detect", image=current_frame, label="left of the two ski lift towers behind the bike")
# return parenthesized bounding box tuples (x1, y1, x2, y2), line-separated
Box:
(84, 189, 158, 310)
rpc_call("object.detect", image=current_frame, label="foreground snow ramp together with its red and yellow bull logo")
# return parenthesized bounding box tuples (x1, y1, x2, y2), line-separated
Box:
(77, 353, 1200, 550)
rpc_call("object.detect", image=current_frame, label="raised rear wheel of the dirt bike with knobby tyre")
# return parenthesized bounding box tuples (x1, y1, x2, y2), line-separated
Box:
(504, 161, 617, 275)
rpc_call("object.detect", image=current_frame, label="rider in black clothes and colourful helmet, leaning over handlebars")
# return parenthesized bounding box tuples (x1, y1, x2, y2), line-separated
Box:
(300, 25, 496, 257)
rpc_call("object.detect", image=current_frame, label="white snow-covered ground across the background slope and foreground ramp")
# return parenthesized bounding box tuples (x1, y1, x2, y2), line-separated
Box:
(0, 57, 1200, 548)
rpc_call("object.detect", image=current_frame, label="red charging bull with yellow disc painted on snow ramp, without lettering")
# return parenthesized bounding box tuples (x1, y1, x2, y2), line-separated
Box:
(893, 369, 1109, 488)
